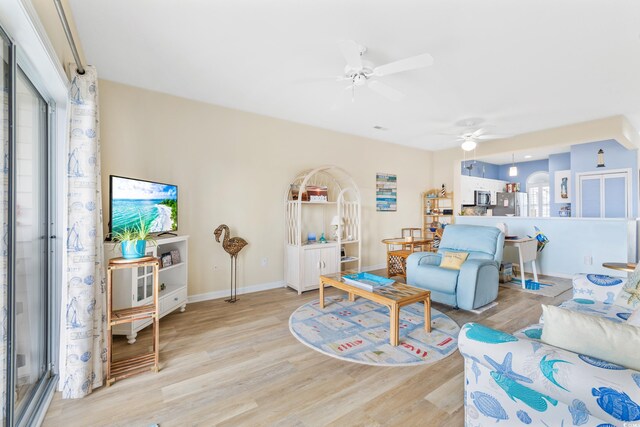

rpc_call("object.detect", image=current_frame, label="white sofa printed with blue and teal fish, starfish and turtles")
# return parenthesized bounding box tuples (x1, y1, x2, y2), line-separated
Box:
(458, 275, 640, 427)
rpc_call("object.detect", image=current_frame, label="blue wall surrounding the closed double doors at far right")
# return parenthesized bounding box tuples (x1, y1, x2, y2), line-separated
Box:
(571, 139, 638, 217)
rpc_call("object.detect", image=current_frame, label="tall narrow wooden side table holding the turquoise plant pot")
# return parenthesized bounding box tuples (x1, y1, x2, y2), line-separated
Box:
(107, 256, 160, 386)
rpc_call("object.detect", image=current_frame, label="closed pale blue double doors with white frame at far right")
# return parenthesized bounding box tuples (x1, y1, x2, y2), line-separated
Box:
(578, 171, 631, 218)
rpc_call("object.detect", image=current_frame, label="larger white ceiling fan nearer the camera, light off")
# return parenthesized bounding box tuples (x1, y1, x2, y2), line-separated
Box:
(338, 40, 433, 101)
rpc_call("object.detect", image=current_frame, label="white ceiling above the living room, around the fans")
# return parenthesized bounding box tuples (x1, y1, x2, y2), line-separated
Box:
(70, 0, 640, 150)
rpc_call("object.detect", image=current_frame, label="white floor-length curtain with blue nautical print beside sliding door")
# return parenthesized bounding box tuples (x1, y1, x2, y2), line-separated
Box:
(61, 66, 107, 399)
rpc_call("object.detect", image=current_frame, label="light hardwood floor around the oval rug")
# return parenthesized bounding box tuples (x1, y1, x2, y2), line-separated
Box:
(44, 271, 571, 427)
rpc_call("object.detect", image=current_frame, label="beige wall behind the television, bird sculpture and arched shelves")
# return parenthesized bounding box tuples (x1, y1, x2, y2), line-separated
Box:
(99, 80, 432, 295)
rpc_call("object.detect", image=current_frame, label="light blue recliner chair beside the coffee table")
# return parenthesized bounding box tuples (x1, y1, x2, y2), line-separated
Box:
(407, 224, 504, 310)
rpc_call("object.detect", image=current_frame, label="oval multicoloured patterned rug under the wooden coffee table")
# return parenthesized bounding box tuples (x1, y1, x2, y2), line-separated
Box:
(289, 296, 460, 366)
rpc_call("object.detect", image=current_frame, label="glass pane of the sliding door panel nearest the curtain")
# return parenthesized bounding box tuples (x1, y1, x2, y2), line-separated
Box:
(13, 67, 49, 424)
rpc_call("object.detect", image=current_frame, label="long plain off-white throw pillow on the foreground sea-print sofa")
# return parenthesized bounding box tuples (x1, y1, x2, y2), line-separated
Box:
(541, 305, 640, 370)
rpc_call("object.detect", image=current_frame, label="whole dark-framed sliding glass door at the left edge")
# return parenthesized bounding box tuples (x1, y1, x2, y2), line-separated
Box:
(0, 25, 52, 426)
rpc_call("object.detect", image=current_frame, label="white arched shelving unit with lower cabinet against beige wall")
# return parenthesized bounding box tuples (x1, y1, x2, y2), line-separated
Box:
(284, 166, 362, 294)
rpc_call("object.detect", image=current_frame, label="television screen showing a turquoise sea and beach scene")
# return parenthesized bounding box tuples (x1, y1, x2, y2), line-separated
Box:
(110, 175, 178, 233)
